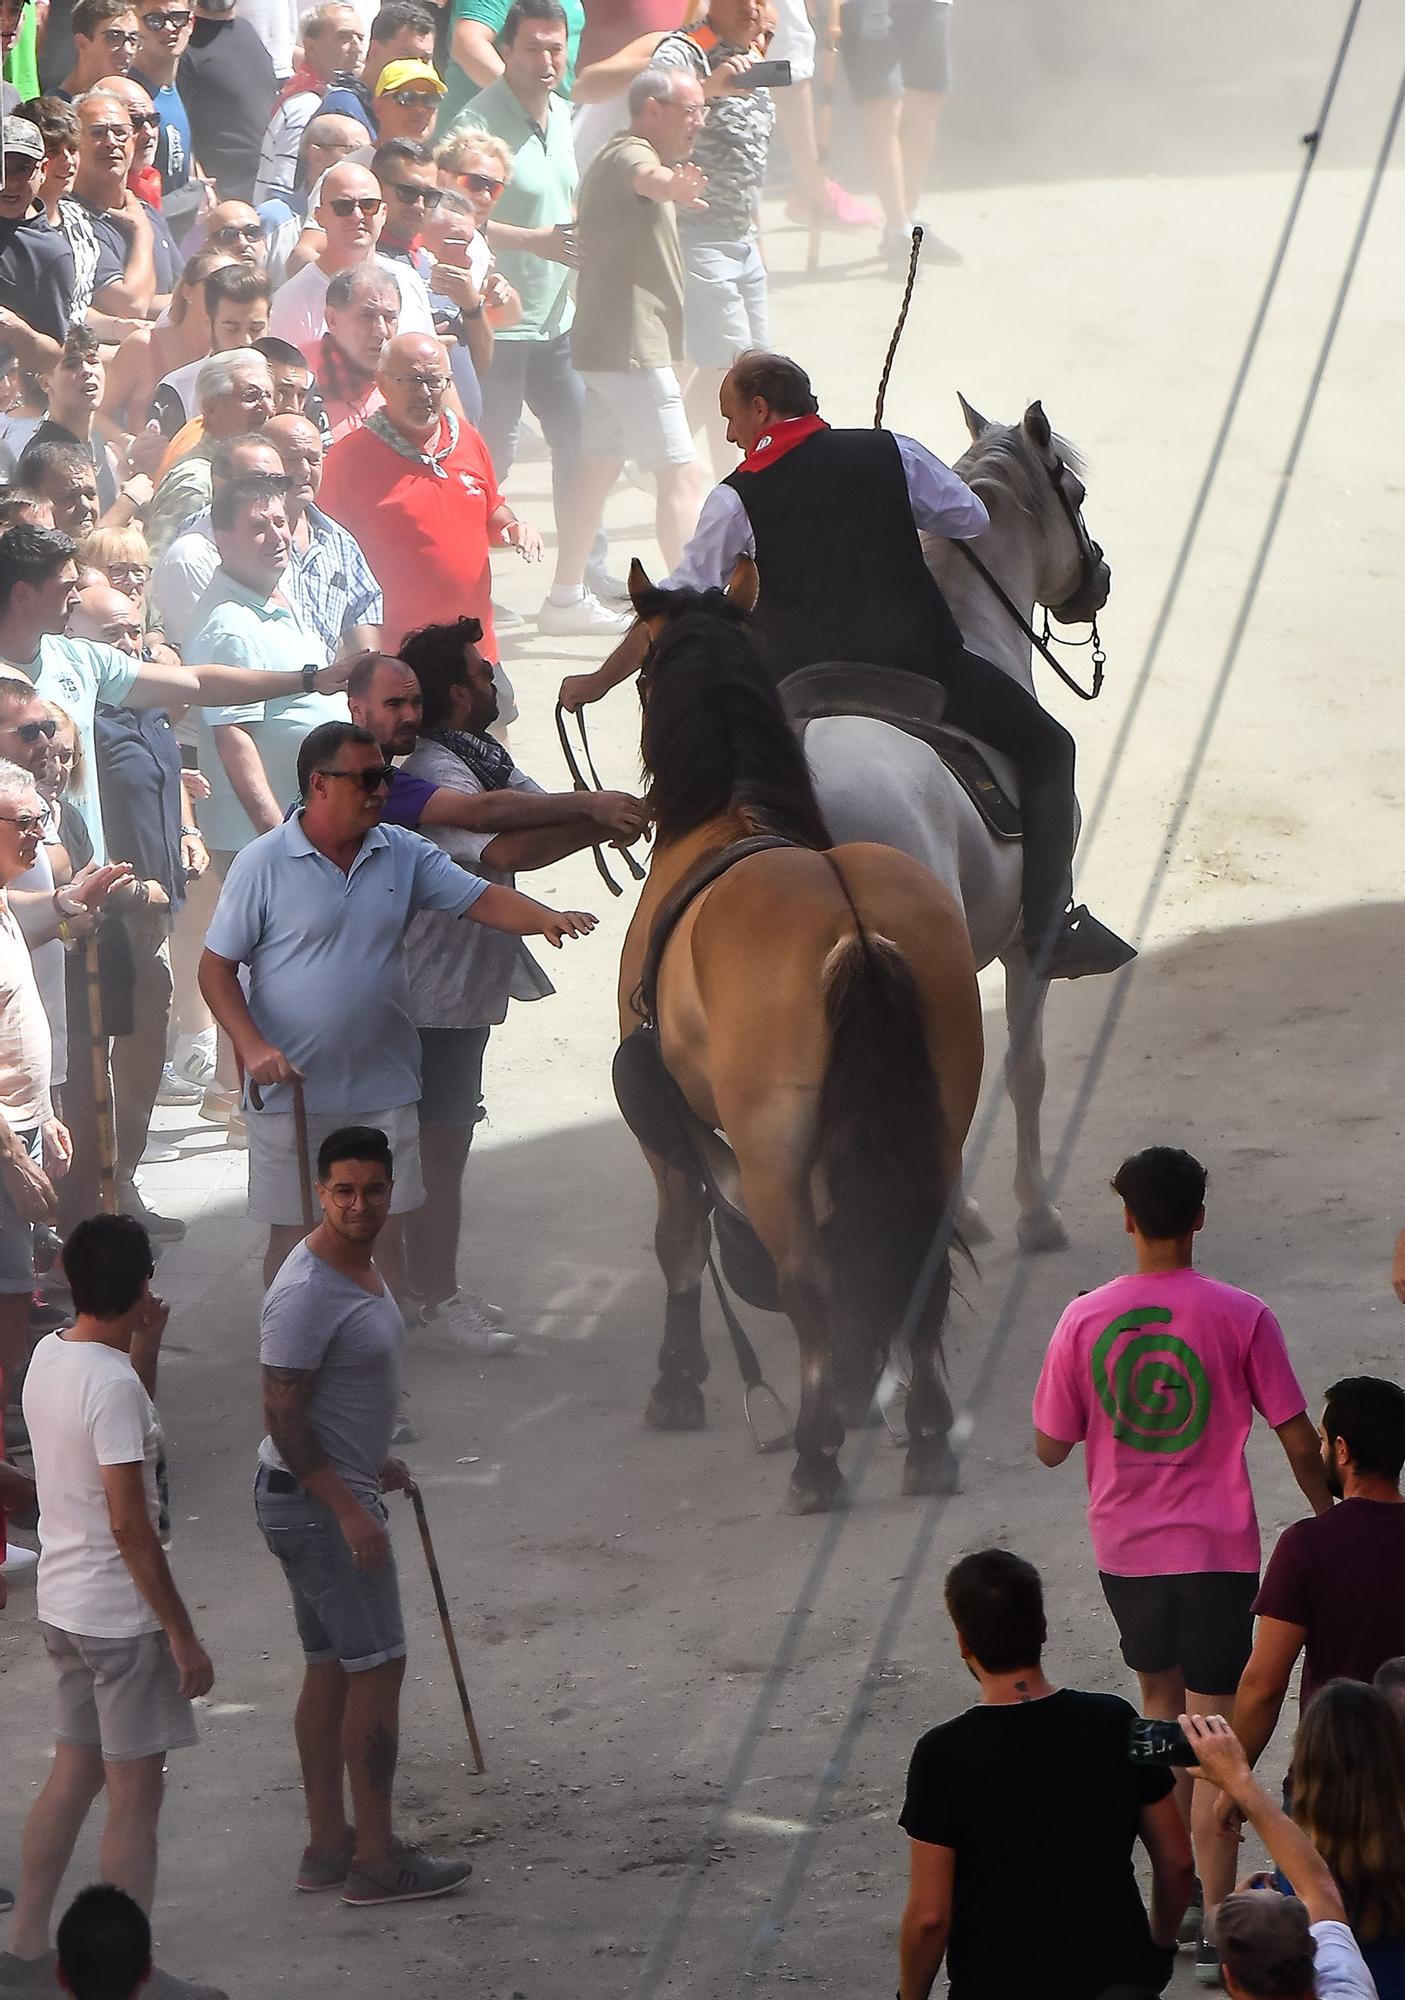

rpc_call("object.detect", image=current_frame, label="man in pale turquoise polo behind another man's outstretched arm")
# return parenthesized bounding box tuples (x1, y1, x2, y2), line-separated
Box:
(186, 474, 350, 866)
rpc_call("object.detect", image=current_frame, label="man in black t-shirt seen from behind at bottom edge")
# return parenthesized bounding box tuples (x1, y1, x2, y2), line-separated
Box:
(901, 1548, 1195, 2000)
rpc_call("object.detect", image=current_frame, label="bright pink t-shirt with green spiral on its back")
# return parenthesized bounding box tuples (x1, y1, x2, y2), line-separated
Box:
(1035, 1266, 1307, 1576)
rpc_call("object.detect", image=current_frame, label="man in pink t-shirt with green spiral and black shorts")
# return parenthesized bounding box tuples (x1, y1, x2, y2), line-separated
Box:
(1035, 1146, 1331, 1980)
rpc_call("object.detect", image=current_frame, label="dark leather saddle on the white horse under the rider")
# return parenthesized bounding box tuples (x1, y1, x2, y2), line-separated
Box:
(781, 660, 1023, 840)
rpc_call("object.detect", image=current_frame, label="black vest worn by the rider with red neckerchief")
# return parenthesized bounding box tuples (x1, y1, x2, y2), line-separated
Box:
(727, 430, 963, 680)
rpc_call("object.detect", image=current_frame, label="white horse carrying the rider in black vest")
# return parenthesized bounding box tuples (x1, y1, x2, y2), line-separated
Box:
(805, 396, 1111, 1250)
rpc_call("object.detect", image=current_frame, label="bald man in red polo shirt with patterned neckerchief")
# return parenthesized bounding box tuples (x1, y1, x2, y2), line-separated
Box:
(318, 334, 542, 660)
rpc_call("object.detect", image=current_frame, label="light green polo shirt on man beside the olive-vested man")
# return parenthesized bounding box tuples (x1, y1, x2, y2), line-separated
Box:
(460, 76, 578, 340)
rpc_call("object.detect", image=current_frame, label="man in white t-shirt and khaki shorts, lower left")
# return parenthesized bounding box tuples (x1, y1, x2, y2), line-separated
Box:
(0, 1216, 214, 2000)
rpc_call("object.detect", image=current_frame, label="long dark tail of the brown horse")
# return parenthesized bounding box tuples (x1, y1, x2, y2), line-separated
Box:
(819, 916, 951, 1428)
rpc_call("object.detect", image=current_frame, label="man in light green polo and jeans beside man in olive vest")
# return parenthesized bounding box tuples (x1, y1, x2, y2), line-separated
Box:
(460, 0, 630, 636)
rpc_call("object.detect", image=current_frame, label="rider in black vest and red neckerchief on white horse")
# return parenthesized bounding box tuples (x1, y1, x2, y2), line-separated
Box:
(560, 352, 1135, 980)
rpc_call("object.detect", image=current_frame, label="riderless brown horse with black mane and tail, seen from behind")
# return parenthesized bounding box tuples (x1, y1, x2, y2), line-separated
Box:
(616, 562, 981, 1514)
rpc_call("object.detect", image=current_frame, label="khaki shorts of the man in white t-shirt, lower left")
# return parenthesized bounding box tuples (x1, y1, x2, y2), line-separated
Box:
(40, 1620, 200, 1764)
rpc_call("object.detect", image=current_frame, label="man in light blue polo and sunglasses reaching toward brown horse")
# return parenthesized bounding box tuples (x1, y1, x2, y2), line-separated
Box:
(200, 722, 594, 1292)
